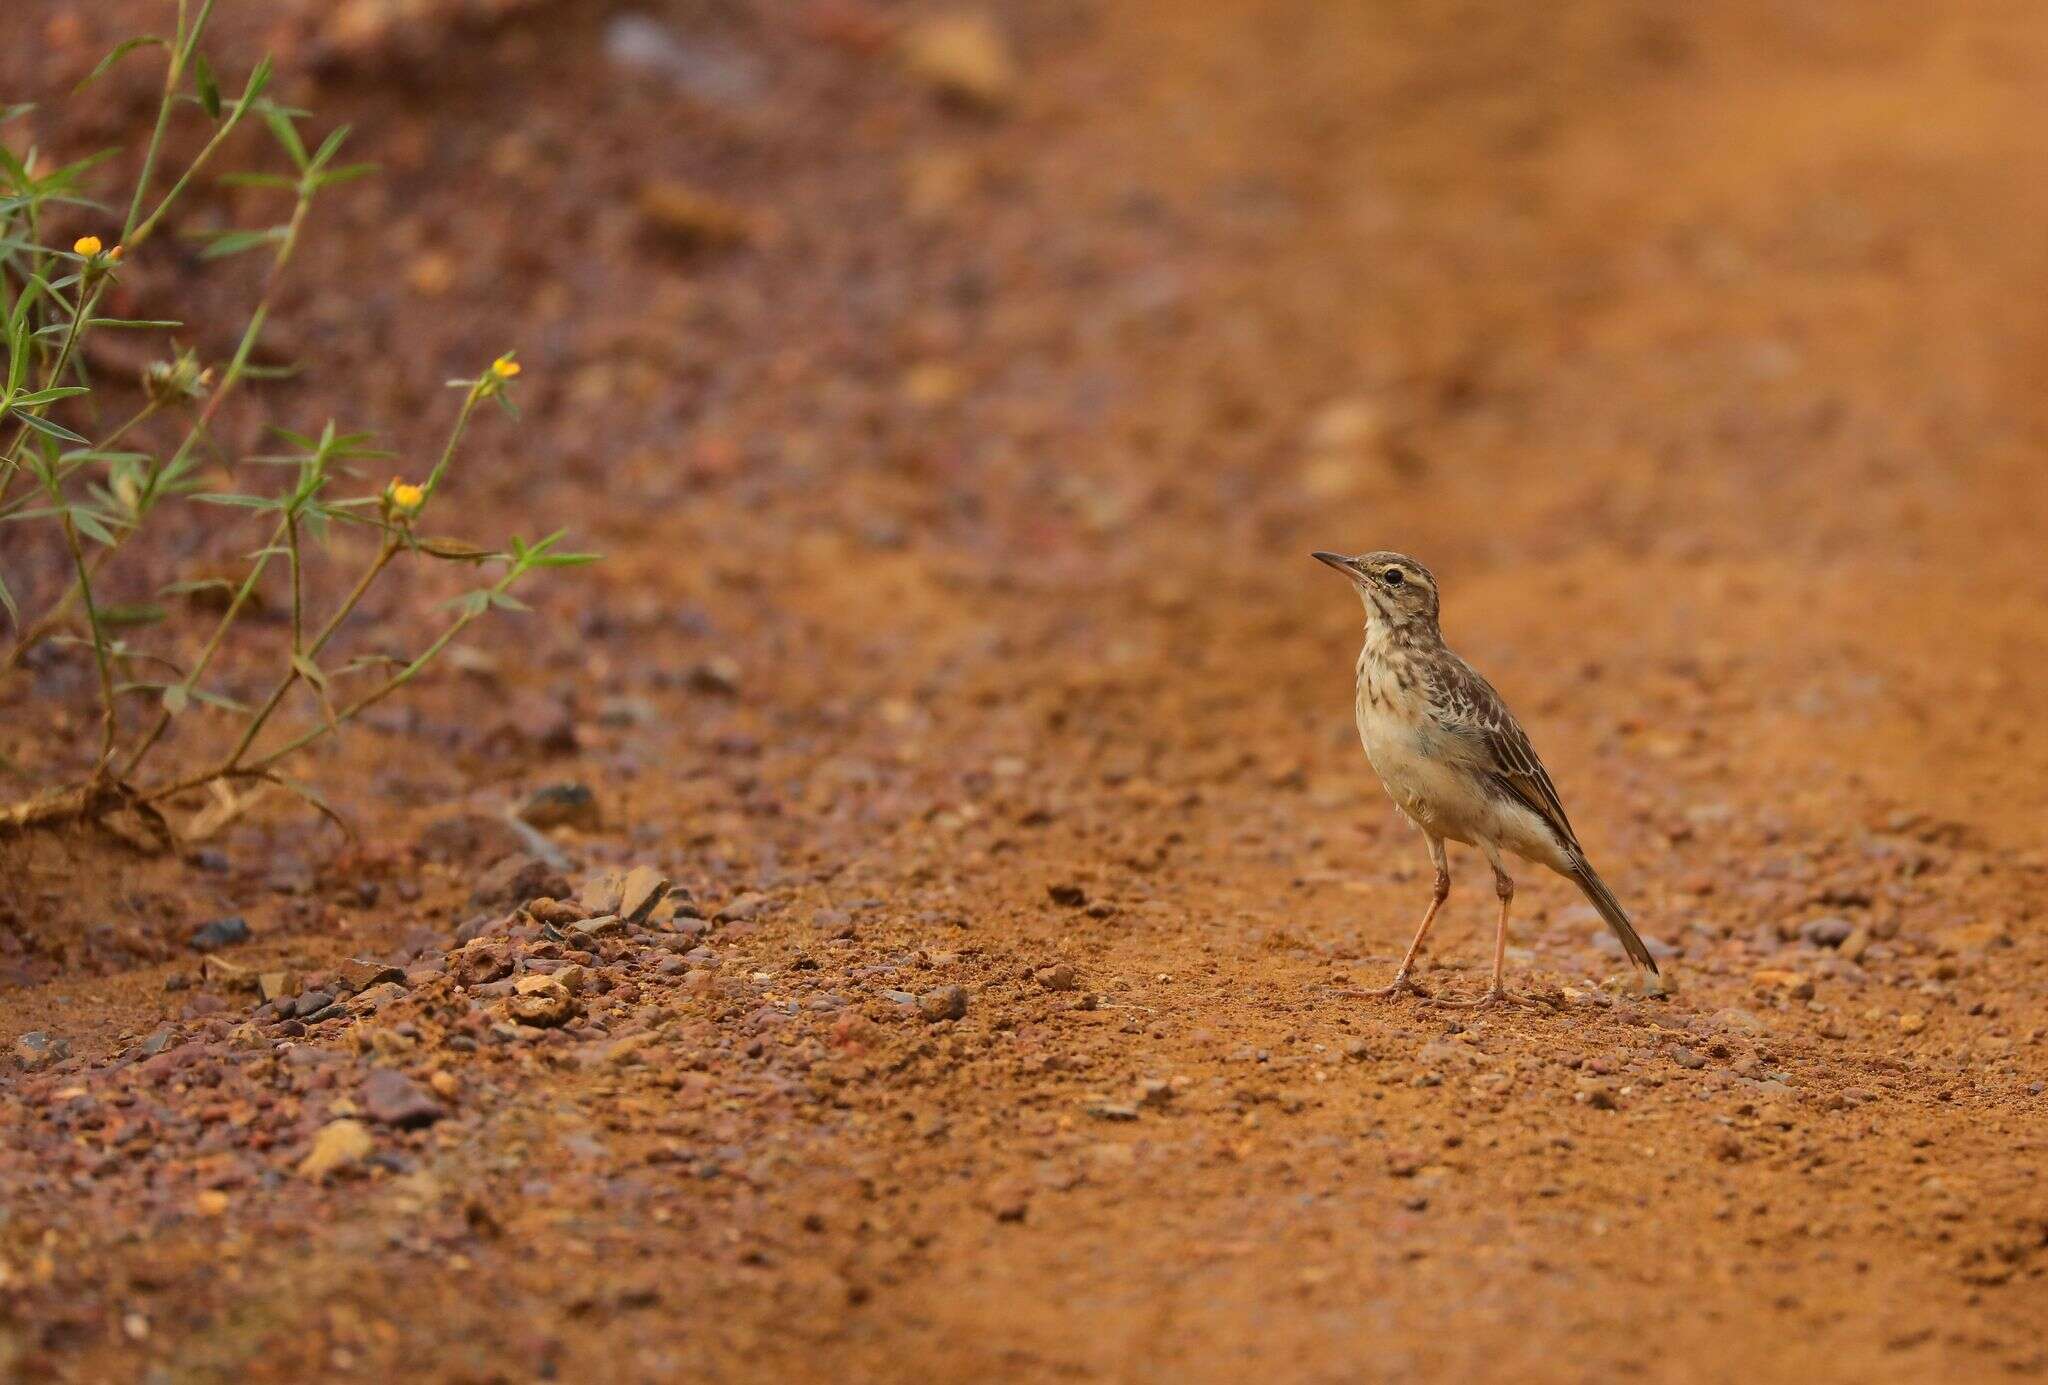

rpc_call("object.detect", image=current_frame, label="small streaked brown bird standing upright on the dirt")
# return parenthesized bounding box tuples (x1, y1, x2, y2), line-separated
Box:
(1313, 551, 1659, 1006)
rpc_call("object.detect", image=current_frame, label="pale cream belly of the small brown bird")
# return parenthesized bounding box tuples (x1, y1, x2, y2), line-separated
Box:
(1358, 697, 1567, 871)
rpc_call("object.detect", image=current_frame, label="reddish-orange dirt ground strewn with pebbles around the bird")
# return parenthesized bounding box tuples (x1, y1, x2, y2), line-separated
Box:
(0, 0, 2048, 1381)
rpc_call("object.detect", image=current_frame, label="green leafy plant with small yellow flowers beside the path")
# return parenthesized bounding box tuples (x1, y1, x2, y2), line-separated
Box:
(0, 0, 594, 844)
